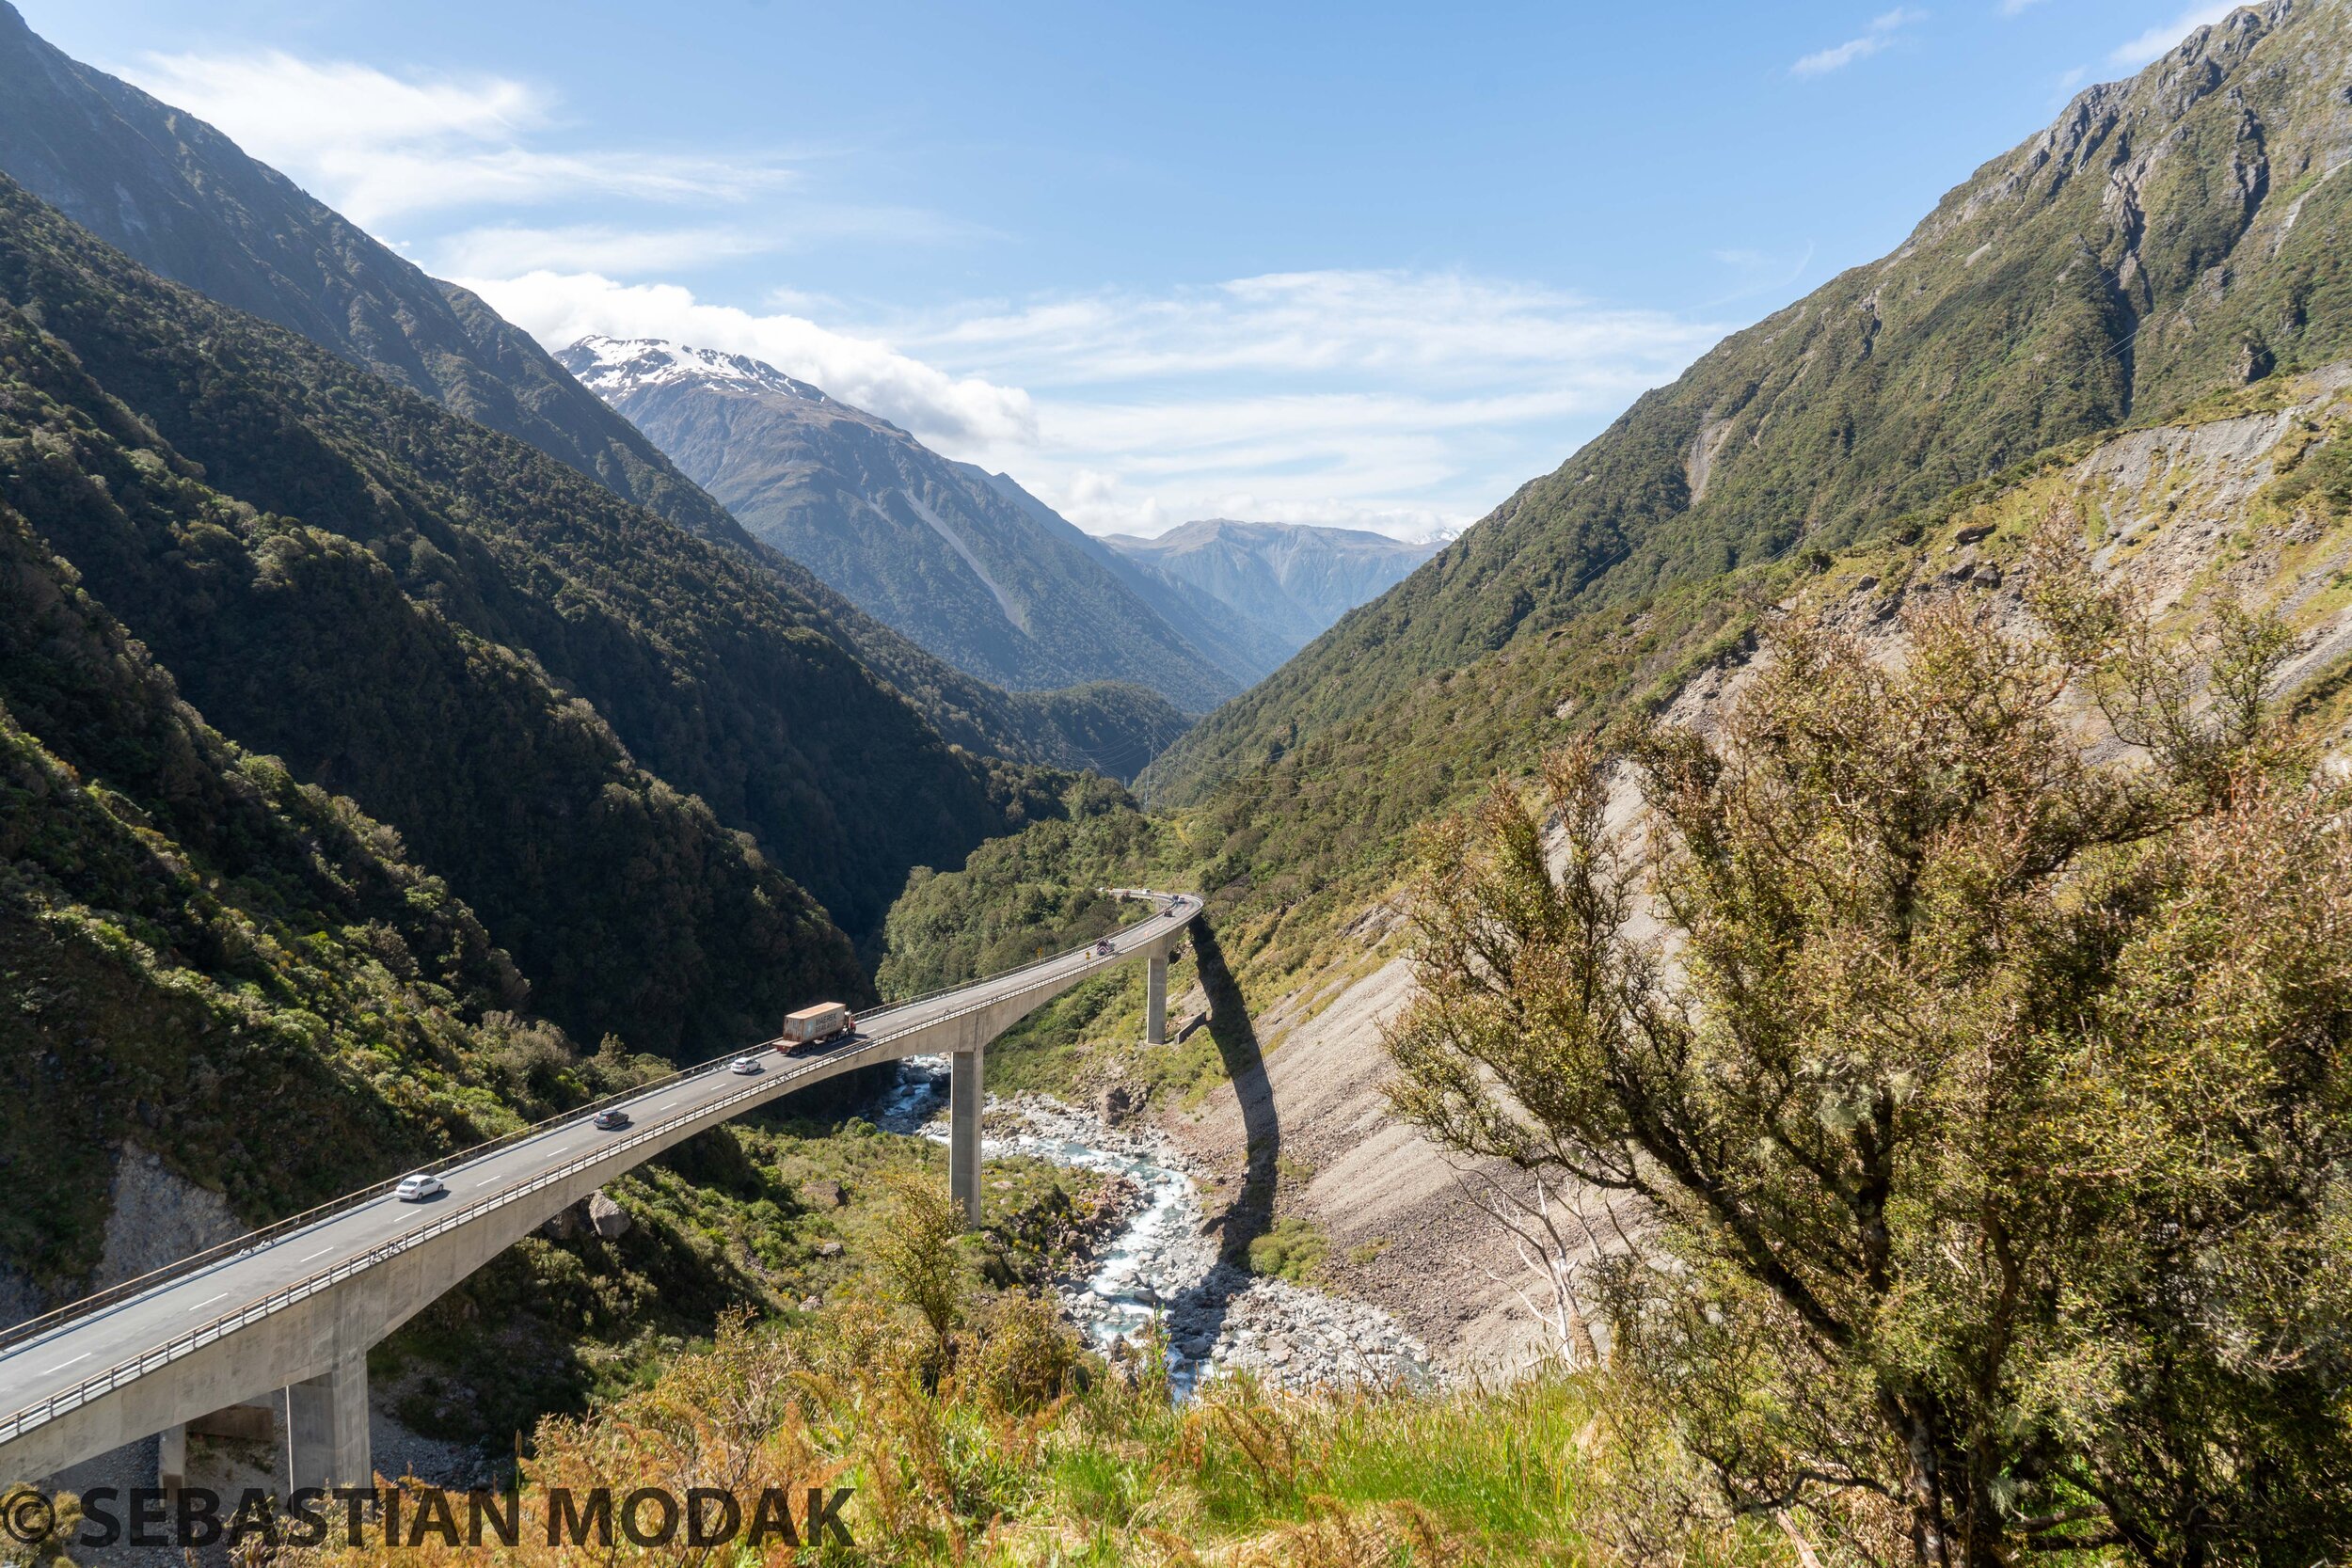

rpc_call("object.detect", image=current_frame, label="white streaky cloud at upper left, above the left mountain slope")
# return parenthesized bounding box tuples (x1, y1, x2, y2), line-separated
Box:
(122, 49, 790, 228)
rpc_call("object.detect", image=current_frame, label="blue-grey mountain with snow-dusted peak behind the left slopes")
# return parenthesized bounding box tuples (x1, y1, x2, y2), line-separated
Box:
(558, 336, 1247, 712)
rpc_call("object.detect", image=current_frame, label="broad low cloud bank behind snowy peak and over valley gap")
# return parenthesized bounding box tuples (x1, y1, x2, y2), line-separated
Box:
(464, 273, 1722, 538)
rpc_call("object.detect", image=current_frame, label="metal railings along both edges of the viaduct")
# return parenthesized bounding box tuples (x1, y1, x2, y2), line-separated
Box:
(0, 889, 1198, 1444)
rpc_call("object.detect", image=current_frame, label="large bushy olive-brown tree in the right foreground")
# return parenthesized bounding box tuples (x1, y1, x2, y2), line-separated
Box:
(1388, 554, 2352, 1568)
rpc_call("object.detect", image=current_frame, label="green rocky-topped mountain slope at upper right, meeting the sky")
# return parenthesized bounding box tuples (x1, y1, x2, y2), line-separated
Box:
(1143, 0, 2352, 800)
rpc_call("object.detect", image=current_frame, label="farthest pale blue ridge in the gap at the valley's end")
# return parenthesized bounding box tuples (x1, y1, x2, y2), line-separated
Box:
(1104, 517, 1444, 651)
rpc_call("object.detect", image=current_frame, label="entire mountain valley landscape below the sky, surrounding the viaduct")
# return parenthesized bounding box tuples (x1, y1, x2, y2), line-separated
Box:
(0, 0, 2352, 1568)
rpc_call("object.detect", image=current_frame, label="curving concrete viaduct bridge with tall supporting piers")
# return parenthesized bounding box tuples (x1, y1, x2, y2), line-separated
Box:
(0, 889, 1200, 1488)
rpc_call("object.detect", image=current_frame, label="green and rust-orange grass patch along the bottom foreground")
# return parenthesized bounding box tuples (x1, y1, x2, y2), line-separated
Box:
(294, 1295, 1788, 1568)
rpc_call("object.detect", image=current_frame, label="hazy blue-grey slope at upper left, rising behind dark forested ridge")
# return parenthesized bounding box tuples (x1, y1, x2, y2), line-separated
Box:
(0, 0, 1181, 776)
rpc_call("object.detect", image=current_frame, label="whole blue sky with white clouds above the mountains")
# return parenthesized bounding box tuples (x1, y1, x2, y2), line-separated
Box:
(17, 0, 2258, 536)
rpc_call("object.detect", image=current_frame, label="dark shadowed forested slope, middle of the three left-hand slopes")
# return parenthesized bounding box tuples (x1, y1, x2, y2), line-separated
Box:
(0, 181, 1052, 1029)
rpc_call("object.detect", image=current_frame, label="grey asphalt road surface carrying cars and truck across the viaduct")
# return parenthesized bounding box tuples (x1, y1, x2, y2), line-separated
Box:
(0, 894, 1200, 1416)
